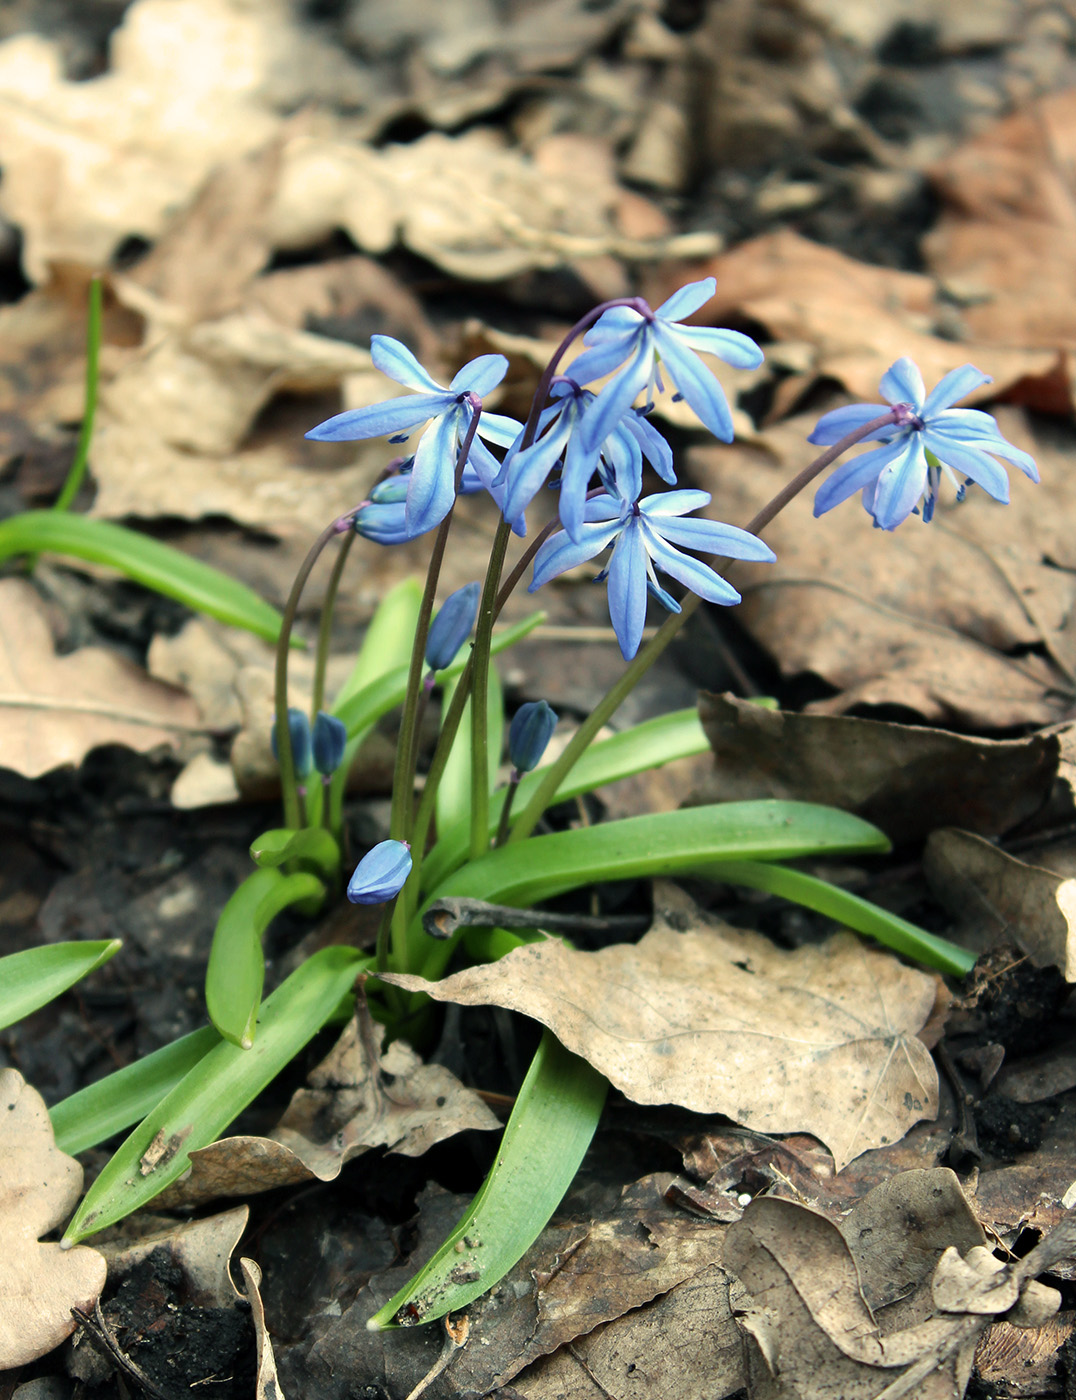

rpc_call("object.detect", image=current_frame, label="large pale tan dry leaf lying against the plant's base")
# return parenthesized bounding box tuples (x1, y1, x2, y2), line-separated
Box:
(385, 886, 937, 1170)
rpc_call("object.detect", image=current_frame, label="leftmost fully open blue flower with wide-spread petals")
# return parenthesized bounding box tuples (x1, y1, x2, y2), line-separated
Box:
(306, 336, 519, 538)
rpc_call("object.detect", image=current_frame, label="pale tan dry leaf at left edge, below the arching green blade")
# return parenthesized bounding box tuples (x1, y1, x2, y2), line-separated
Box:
(0, 578, 200, 777)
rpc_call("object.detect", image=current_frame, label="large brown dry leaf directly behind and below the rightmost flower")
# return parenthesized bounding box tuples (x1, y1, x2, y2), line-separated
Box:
(688, 414, 1076, 729)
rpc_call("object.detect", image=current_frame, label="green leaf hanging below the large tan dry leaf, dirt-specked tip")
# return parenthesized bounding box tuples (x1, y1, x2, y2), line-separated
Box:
(367, 1030, 609, 1329)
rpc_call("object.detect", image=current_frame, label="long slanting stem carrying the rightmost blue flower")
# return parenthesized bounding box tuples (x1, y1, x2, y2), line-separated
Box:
(508, 405, 902, 841)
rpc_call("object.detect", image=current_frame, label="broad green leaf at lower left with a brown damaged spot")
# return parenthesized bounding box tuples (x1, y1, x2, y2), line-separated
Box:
(63, 946, 369, 1246)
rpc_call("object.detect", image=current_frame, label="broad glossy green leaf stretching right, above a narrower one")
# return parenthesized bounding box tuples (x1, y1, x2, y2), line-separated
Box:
(409, 801, 889, 977)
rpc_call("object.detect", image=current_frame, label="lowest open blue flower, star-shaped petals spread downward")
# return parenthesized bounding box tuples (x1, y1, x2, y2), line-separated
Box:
(529, 491, 775, 661)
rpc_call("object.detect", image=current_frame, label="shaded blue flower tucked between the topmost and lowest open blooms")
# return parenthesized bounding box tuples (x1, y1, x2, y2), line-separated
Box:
(497, 377, 676, 540)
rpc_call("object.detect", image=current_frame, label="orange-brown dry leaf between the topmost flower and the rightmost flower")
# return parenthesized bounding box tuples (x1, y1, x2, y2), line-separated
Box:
(651, 230, 1058, 412)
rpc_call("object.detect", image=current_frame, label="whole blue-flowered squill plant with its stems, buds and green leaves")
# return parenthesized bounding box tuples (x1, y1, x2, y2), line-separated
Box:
(57, 279, 1035, 1326)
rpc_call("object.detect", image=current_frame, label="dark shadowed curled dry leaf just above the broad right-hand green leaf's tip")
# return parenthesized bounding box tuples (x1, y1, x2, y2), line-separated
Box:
(697, 692, 1059, 841)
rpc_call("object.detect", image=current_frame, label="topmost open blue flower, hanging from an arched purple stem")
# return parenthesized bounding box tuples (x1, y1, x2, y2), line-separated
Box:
(568, 277, 763, 451)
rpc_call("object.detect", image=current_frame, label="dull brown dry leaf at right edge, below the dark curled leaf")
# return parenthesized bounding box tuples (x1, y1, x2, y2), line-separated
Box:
(923, 830, 1076, 981)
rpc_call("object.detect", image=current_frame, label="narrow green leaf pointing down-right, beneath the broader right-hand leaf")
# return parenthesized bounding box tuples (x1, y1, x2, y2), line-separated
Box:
(705, 861, 975, 977)
